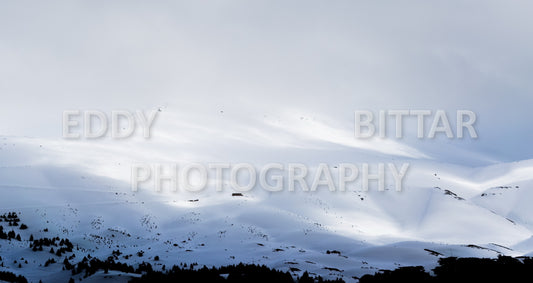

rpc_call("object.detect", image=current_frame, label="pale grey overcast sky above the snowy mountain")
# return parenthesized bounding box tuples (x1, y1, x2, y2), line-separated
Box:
(0, 1, 533, 171)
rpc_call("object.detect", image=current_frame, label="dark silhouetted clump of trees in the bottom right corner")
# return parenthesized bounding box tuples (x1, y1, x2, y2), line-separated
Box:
(359, 256, 533, 283)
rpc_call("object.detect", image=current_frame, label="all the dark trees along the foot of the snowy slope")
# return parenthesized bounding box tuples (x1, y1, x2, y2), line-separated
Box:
(7, 212, 533, 283)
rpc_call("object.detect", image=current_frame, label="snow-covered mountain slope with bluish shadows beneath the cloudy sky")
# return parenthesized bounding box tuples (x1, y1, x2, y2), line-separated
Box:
(0, 137, 533, 282)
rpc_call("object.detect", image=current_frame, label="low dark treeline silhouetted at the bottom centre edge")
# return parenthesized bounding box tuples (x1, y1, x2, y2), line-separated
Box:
(129, 263, 344, 283)
